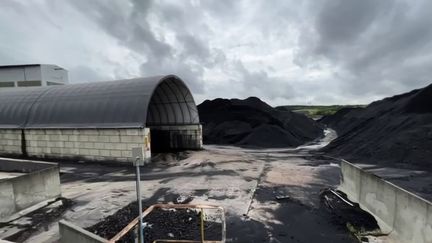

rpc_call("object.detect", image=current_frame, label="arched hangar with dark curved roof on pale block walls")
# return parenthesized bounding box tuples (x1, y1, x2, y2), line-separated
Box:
(0, 75, 202, 162)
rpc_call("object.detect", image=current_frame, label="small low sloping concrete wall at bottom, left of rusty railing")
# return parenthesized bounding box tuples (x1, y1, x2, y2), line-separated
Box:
(59, 220, 108, 243)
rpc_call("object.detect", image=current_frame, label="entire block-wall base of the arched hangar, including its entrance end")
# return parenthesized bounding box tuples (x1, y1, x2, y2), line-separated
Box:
(0, 125, 203, 162)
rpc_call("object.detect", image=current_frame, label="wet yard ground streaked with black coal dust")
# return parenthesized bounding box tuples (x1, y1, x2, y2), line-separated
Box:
(21, 130, 355, 243)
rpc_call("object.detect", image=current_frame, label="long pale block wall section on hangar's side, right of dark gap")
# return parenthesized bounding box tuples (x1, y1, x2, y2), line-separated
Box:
(25, 128, 151, 162)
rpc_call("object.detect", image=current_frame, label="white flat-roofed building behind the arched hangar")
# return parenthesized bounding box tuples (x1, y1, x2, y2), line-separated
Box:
(0, 64, 68, 88)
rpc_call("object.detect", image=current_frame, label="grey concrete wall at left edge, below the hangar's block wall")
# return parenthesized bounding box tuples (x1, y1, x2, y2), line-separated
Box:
(0, 159, 61, 221)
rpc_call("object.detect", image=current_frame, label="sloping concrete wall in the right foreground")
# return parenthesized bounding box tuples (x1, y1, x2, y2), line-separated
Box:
(339, 160, 432, 243)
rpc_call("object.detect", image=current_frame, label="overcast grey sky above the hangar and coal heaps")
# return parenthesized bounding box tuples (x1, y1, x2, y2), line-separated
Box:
(0, 0, 432, 105)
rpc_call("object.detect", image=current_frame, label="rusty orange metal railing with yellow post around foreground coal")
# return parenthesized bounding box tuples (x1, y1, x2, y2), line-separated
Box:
(108, 204, 226, 243)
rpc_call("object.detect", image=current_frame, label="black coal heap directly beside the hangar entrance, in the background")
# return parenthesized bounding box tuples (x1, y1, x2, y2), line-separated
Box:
(198, 97, 323, 148)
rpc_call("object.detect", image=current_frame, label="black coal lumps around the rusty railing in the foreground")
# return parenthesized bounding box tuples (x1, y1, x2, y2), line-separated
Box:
(87, 202, 222, 243)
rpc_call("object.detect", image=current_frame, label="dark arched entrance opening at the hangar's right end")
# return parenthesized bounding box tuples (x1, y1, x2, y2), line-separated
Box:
(146, 77, 202, 153)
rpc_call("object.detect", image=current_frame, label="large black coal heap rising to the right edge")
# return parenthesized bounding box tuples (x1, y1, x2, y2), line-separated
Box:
(321, 85, 432, 170)
